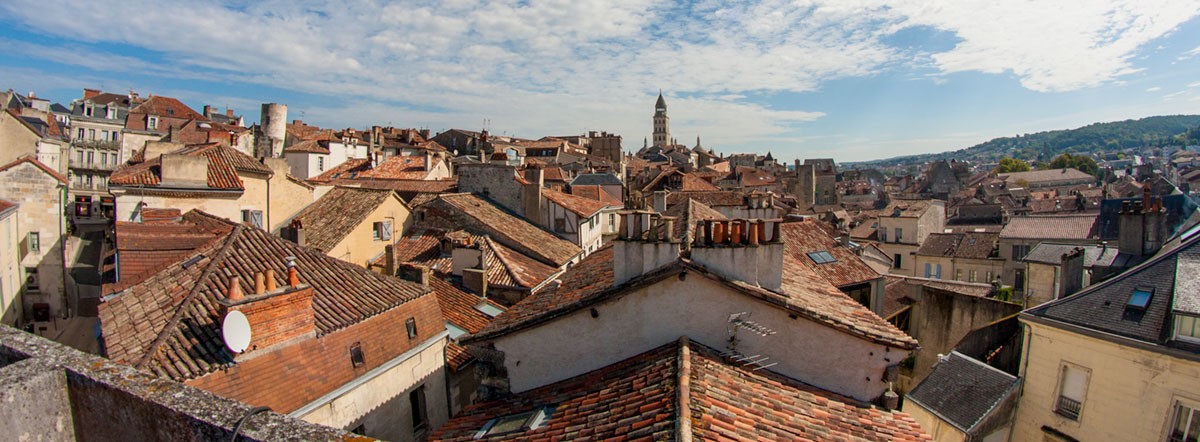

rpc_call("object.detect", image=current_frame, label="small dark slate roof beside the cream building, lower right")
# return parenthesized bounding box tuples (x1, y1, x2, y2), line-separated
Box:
(907, 352, 1018, 432)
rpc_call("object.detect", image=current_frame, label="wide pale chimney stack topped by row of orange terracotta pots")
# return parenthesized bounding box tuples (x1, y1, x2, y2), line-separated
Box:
(691, 219, 784, 291)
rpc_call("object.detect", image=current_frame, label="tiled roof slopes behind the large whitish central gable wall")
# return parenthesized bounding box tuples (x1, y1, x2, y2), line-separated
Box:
(468, 244, 917, 350)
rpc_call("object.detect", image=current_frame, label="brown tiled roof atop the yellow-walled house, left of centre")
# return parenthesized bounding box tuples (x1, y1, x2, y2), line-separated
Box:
(292, 187, 403, 253)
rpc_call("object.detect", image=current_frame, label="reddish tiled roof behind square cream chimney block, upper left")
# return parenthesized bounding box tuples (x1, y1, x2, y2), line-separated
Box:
(109, 143, 271, 190)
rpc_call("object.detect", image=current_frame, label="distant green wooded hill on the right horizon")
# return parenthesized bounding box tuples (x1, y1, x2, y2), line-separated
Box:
(856, 115, 1200, 166)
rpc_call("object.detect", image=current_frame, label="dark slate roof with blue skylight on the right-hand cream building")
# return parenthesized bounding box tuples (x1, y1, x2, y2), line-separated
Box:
(1021, 229, 1200, 345)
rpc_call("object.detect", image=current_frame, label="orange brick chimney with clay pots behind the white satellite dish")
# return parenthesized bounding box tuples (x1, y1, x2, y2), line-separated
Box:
(217, 268, 317, 352)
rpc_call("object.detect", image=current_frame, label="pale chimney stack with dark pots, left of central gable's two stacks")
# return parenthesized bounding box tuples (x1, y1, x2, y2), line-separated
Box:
(612, 210, 679, 286)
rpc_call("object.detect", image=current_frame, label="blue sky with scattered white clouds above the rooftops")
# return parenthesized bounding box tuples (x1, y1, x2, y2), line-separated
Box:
(0, 0, 1200, 162)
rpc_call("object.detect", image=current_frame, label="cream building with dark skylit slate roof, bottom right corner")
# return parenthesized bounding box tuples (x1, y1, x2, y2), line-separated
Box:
(1012, 228, 1200, 441)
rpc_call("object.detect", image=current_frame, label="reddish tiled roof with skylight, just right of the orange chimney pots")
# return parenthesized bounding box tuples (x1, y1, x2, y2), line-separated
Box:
(781, 219, 881, 287)
